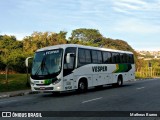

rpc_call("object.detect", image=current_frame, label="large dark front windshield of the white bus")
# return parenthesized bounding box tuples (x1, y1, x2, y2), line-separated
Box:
(31, 49, 63, 79)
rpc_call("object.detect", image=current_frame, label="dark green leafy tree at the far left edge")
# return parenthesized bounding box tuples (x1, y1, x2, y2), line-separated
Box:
(0, 35, 23, 70)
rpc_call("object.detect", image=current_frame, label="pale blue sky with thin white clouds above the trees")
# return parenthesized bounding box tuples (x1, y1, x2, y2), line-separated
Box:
(0, 0, 160, 51)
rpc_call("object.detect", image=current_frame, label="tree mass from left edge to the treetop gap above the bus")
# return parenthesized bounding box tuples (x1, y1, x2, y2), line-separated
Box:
(0, 31, 67, 73)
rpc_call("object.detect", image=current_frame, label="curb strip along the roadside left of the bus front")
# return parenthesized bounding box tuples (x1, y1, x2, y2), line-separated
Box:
(0, 91, 40, 99)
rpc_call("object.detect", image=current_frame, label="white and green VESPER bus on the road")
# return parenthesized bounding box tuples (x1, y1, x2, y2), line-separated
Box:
(30, 44, 135, 92)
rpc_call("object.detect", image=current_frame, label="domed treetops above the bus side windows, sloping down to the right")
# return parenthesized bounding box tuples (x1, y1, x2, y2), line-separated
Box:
(69, 28, 134, 52)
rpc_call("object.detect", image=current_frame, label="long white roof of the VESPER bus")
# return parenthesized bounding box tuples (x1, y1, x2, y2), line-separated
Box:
(36, 44, 133, 54)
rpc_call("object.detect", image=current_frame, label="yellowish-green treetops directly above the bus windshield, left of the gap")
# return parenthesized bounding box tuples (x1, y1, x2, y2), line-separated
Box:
(23, 31, 67, 54)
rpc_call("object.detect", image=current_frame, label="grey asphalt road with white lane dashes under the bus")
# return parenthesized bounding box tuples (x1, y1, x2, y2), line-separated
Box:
(0, 79, 160, 120)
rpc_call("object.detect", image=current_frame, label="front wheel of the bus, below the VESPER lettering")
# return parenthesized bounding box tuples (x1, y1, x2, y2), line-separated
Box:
(78, 80, 88, 93)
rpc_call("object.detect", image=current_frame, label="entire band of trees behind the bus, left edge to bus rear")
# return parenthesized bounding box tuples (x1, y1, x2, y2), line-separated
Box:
(0, 28, 138, 73)
